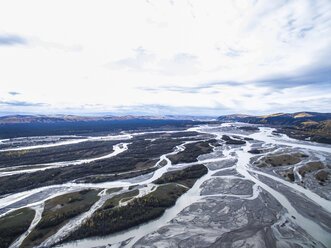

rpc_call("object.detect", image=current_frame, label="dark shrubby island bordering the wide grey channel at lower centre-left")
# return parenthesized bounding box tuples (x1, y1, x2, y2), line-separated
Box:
(63, 165, 208, 242)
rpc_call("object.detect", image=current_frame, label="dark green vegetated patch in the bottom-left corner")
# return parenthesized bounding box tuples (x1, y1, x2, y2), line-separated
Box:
(0, 208, 35, 248)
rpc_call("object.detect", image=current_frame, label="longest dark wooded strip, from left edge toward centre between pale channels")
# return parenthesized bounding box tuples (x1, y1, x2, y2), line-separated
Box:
(0, 132, 197, 195)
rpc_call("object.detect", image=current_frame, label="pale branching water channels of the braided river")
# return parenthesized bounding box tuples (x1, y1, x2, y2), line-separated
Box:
(0, 124, 331, 248)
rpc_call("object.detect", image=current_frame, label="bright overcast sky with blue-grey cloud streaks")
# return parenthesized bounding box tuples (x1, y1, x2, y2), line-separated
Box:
(0, 0, 331, 116)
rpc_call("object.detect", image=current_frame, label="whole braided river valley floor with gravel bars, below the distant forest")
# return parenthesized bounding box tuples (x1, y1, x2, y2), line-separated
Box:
(0, 123, 331, 248)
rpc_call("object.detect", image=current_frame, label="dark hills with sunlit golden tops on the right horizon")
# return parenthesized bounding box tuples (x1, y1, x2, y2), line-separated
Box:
(217, 112, 331, 144)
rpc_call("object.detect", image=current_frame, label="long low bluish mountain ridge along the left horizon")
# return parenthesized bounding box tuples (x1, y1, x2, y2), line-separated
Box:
(0, 115, 216, 124)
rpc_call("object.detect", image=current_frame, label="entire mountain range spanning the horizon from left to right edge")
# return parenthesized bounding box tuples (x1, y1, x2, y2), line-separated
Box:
(0, 112, 331, 144)
